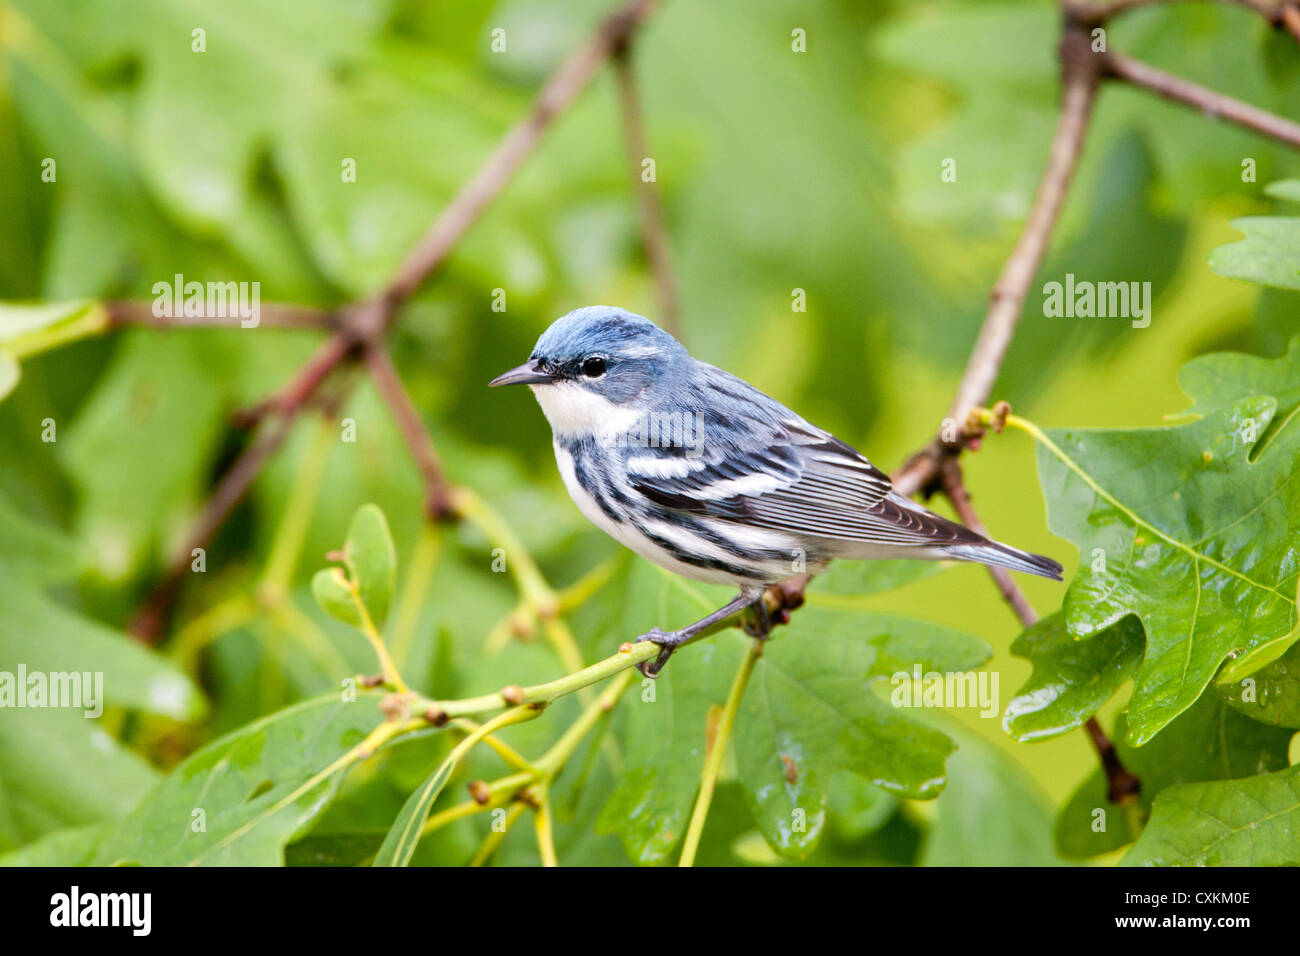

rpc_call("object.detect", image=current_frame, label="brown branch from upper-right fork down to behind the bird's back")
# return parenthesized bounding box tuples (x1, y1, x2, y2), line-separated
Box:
(893, 23, 1100, 496)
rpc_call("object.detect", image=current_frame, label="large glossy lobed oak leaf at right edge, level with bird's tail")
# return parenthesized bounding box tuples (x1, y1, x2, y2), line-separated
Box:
(1039, 339, 1300, 744)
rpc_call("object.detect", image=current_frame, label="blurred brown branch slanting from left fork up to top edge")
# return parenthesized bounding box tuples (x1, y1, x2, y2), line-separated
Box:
(385, 0, 657, 310)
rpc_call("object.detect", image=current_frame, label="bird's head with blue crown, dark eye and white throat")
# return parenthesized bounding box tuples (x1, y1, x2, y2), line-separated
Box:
(489, 306, 690, 436)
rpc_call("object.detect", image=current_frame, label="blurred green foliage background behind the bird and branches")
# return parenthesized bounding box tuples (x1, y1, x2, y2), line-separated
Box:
(0, 0, 1300, 864)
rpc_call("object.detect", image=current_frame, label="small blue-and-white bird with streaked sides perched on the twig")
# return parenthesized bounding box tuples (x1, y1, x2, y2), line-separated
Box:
(489, 306, 1062, 676)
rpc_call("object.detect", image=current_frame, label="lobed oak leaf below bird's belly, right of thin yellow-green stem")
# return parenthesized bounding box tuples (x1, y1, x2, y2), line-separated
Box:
(733, 607, 992, 858)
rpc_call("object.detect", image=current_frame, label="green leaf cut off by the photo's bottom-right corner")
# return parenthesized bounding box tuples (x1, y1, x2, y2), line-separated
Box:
(1122, 763, 1300, 866)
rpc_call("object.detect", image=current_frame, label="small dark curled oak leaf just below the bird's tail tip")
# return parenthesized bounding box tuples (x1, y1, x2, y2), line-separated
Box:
(1002, 613, 1145, 744)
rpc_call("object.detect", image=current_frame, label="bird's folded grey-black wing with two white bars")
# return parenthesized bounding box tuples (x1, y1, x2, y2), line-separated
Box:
(625, 419, 982, 545)
